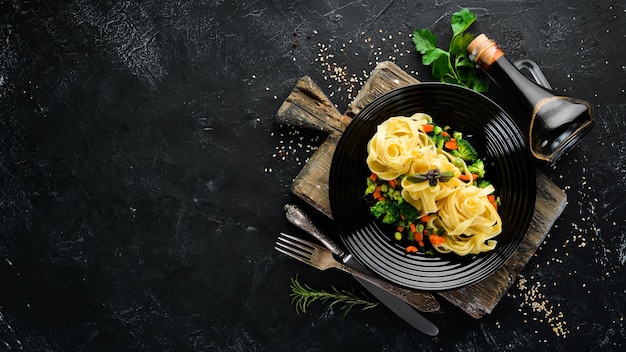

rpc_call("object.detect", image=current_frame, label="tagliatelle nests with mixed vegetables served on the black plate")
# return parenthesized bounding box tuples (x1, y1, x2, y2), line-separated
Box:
(365, 113, 502, 256)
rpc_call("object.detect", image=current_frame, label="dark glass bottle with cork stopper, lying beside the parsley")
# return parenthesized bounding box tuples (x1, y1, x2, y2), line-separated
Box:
(467, 34, 594, 163)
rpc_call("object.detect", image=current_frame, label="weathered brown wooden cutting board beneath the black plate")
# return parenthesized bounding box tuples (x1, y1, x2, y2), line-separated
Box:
(275, 62, 567, 319)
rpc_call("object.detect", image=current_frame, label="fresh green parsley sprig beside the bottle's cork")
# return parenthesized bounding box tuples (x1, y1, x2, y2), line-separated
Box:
(412, 9, 489, 92)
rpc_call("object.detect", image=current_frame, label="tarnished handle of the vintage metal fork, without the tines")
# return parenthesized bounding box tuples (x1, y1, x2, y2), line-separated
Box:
(332, 261, 439, 312)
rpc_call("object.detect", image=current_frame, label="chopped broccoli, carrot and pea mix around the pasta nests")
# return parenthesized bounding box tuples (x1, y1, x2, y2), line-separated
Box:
(365, 124, 500, 254)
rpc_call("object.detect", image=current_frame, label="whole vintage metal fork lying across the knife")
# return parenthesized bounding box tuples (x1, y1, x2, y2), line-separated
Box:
(274, 232, 438, 311)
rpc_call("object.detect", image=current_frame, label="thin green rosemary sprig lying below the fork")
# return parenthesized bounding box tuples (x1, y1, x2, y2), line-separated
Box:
(289, 275, 378, 316)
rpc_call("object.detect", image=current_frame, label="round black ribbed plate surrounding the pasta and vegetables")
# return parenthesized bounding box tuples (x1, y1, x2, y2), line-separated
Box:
(329, 83, 536, 291)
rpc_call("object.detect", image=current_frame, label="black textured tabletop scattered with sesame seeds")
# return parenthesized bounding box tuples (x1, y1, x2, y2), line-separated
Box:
(0, 0, 626, 351)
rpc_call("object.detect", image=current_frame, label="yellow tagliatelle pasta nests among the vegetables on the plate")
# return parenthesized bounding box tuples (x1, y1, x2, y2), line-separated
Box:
(366, 113, 502, 255)
